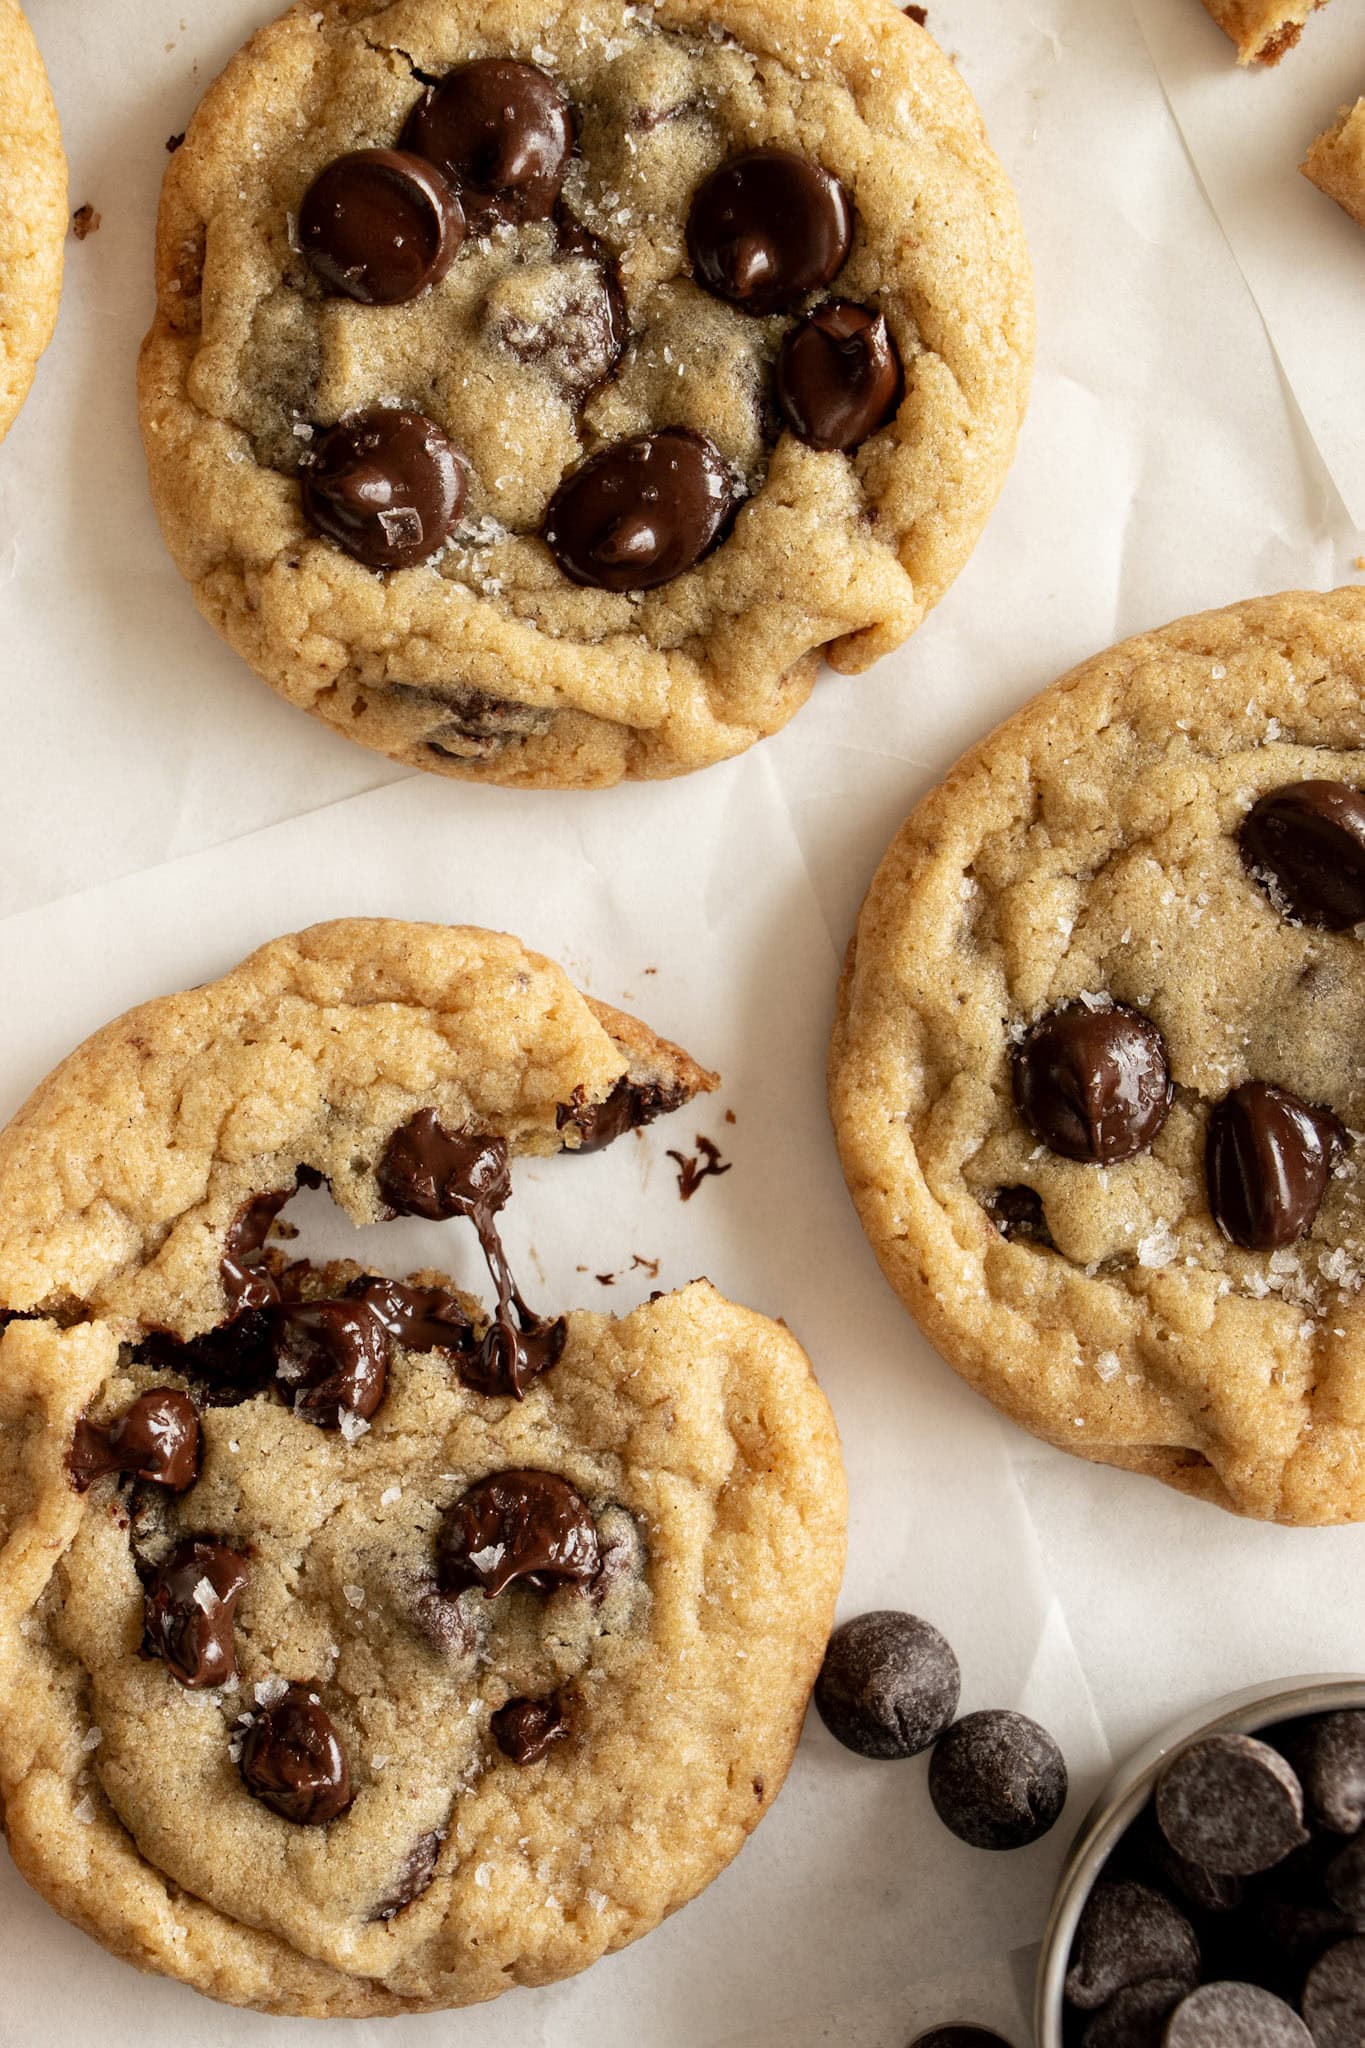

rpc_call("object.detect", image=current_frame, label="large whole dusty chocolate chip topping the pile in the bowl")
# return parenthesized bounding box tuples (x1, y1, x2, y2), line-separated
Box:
(1156, 1735, 1308, 1878)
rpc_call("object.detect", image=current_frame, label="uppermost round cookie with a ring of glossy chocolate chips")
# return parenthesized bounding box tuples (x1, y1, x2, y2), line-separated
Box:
(141, 0, 1033, 786)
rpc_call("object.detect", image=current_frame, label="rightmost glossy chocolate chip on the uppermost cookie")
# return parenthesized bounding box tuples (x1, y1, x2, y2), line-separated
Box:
(778, 299, 905, 453)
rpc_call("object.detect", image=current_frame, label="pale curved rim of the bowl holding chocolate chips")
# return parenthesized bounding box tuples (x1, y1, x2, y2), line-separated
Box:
(1033, 1671, 1365, 2048)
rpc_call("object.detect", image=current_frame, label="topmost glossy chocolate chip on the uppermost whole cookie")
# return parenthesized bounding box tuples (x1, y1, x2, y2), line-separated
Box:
(403, 57, 573, 236)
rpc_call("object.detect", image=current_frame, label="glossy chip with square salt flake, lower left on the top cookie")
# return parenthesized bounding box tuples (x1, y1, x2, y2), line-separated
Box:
(301, 406, 469, 569)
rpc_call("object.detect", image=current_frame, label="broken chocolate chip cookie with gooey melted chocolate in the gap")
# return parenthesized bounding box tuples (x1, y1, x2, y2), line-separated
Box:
(0, 922, 843, 2015)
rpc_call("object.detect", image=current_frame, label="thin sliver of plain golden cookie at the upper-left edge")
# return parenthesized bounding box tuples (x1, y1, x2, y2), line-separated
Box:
(0, 0, 65, 440)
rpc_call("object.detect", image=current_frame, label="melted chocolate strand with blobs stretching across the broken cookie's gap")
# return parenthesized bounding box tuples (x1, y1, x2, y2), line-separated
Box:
(379, 1110, 569, 1401)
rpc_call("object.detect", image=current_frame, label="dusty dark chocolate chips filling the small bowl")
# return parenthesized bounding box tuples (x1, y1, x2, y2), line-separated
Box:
(1066, 1712, 1365, 2048)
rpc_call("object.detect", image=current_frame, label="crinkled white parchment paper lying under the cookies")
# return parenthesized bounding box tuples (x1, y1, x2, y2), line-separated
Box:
(0, 0, 1365, 2048)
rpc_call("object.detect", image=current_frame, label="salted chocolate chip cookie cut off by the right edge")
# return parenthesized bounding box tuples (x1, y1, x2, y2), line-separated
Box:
(831, 590, 1365, 1524)
